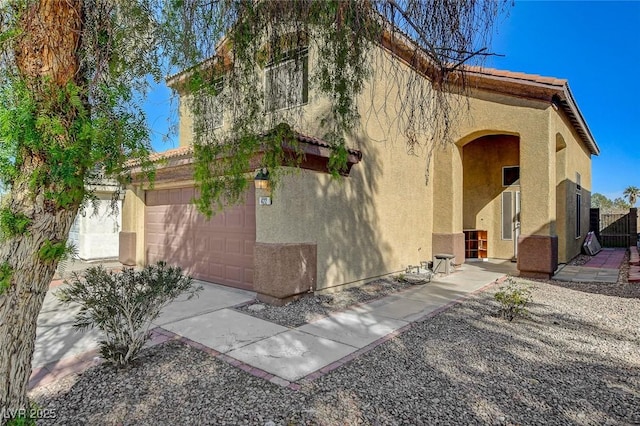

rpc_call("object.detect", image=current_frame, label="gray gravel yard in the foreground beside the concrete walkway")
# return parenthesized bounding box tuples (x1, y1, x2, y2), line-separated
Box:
(31, 272, 640, 425)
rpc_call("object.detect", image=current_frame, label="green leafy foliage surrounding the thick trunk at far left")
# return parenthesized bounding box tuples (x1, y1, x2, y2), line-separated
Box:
(0, 1, 162, 208)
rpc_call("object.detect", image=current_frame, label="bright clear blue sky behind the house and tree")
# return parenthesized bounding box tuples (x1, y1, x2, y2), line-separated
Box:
(146, 1, 640, 198)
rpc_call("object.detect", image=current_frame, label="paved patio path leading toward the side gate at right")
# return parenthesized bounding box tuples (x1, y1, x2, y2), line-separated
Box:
(553, 248, 626, 283)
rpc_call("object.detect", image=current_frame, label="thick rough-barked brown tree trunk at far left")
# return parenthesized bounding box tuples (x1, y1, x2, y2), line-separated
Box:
(0, 0, 88, 423)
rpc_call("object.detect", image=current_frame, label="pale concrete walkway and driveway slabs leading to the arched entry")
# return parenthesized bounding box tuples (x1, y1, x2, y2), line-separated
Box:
(30, 262, 516, 389)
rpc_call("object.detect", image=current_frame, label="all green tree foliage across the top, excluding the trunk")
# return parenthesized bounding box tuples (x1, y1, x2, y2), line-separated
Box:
(0, 0, 504, 218)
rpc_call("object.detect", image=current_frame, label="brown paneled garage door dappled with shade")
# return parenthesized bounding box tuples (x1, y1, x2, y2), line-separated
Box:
(145, 188, 256, 289)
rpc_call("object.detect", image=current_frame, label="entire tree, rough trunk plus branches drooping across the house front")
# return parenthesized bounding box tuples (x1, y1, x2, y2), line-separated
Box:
(0, 0, 505, 416)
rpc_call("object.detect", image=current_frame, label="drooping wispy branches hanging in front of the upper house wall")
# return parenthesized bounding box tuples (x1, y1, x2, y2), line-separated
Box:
(163, 0, 506, 214)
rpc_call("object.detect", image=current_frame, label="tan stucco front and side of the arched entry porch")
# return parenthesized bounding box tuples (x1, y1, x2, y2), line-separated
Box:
(448, 92, 591, 262)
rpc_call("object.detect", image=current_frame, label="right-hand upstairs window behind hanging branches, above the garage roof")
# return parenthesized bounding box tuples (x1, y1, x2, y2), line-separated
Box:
(264, 49, 309, 111)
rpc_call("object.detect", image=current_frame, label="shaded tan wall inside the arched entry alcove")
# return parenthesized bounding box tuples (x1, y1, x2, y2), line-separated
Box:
(463, 135, 520, 259)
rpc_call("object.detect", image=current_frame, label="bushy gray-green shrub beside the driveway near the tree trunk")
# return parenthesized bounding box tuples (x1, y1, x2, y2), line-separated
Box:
(56, 262, 202, 367)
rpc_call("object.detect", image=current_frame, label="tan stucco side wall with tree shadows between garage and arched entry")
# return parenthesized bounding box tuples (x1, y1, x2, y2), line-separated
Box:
(256, 47, 442, 289)
